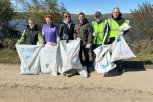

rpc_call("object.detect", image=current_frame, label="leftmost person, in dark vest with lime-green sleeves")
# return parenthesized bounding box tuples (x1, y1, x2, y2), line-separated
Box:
(17, 19, 44, 45)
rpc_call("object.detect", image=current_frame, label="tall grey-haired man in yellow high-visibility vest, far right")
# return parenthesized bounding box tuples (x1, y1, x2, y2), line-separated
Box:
(104, 7, 129, 76)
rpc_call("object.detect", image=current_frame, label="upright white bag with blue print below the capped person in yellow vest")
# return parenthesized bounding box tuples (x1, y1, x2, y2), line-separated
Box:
(94, 45, 116, 73)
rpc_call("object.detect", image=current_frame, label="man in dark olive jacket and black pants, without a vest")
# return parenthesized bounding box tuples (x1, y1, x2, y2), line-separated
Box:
(74, 12, 93, 71)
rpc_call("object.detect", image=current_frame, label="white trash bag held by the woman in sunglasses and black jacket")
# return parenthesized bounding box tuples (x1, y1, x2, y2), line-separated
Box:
(60, 40, 88, 77)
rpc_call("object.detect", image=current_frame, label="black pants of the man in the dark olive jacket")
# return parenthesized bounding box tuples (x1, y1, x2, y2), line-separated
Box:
(79, 44, 89, 68)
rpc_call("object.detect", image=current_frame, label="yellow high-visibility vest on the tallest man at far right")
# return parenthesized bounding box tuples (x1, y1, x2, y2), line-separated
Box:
(108, 19, 129, 40)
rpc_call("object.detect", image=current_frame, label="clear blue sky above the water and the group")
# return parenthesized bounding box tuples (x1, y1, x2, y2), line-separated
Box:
(11, 0, 153, 14)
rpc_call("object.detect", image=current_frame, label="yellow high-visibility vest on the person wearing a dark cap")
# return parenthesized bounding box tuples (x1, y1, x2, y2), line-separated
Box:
(92, 21, 106, 44)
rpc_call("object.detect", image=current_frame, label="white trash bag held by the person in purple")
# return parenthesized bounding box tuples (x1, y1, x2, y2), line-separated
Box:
(40, 44, 58, 76)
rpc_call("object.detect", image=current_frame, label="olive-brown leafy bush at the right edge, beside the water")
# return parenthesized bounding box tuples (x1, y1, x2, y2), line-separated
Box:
(131, 2, 153, 40)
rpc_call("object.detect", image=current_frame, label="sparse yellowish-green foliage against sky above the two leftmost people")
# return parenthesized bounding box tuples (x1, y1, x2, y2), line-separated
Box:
(15, 0, 66, 27)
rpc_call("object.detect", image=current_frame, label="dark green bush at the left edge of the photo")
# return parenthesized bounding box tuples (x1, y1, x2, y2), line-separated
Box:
(0, 0, 19, 47)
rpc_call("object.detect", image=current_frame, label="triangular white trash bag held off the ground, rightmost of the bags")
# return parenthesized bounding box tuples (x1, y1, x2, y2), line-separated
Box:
(111, 36, 136, 62)
